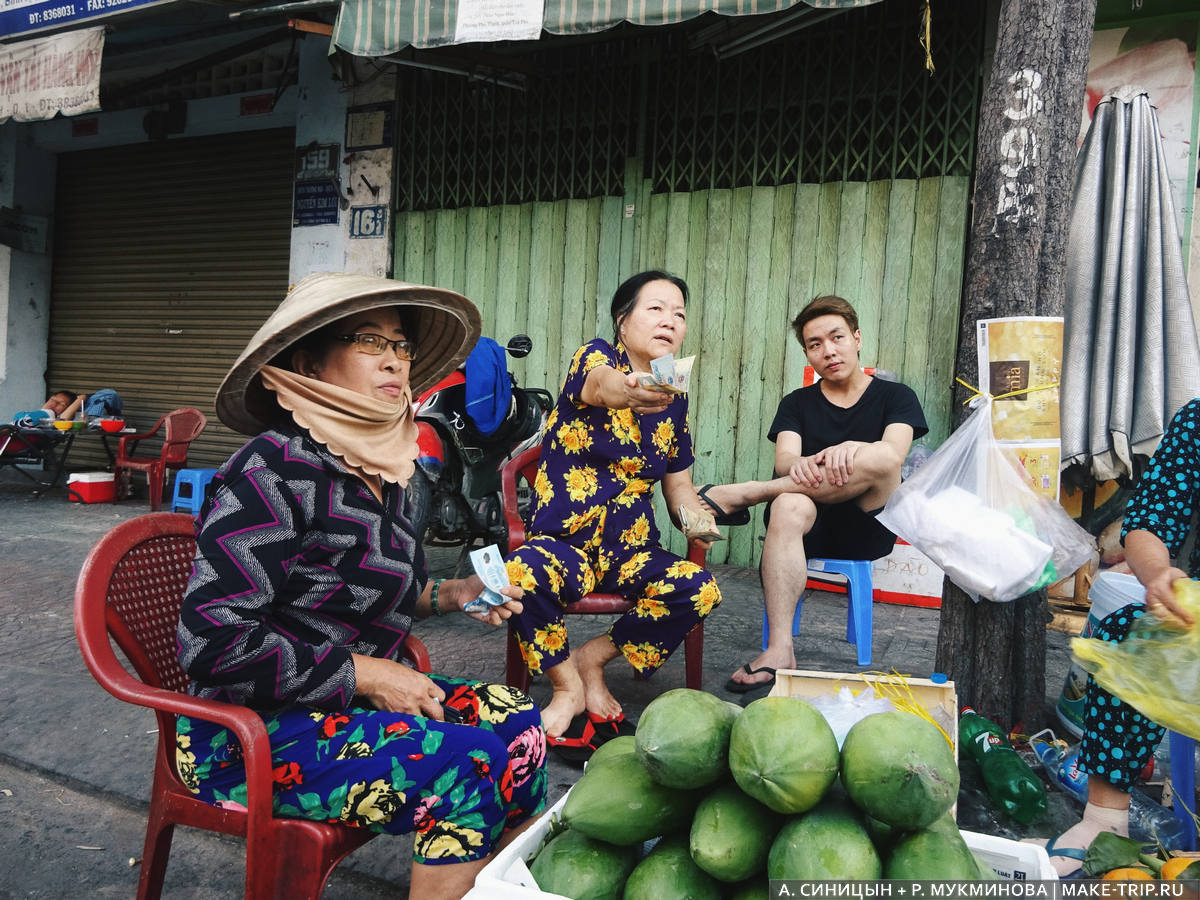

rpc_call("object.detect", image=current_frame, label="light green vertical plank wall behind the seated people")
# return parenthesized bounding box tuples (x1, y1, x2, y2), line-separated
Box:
(395, 178, 968, 565)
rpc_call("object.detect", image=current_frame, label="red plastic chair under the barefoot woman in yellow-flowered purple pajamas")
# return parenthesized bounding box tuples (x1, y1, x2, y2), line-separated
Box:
(500, 446, 708, 690)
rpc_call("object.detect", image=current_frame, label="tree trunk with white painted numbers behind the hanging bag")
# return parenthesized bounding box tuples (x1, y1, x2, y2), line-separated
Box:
(937, 0, 1096, 727)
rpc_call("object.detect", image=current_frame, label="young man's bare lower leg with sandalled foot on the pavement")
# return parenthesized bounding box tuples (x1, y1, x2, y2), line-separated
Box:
(714, 494, 817, 684)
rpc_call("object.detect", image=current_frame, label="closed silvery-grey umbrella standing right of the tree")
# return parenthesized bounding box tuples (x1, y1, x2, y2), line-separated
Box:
(1061, 89, 1200, 481)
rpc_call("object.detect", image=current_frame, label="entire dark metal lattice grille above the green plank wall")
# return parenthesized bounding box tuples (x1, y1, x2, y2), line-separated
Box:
(397, 0, 985, 211)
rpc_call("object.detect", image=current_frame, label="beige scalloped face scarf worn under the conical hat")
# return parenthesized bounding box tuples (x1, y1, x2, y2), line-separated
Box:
(260, 366, 416, 487)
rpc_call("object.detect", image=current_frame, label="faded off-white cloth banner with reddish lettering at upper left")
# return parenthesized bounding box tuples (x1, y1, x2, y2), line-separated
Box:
(0, 25, 104, 122)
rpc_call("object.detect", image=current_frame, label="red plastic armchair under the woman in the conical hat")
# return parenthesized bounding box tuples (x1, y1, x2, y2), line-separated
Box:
(74, 512, 430, 900)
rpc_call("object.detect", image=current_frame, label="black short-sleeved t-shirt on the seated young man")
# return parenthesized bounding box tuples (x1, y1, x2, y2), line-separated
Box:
(767, 378, 929, 456)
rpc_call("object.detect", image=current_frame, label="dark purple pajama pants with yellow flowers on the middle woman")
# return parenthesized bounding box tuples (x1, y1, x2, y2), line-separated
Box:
(508, 535, 721, 677)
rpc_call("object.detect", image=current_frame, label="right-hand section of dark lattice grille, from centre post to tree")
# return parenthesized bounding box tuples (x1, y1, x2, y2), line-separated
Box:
(646, 2, 983, 192)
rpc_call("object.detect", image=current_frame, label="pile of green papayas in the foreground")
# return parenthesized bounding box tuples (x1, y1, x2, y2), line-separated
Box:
(530, 689, 996, 900)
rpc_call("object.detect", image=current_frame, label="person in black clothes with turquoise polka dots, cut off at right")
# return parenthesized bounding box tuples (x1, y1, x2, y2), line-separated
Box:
(1046, 400, 1200, 875)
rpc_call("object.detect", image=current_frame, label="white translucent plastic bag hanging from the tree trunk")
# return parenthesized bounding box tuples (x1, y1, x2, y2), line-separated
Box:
(878, 398, 1096, 601)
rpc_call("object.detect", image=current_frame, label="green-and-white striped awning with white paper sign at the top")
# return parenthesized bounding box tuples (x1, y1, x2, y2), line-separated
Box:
(334, 0, 880, 56)
